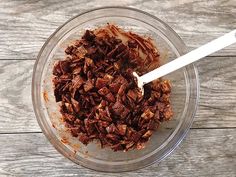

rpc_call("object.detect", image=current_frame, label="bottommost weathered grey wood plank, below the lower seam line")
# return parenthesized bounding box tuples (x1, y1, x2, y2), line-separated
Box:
(0, 129, 236, 177)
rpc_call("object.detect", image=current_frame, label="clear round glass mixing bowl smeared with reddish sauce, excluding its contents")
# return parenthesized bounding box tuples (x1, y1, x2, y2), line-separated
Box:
(32, 7, 199, 172)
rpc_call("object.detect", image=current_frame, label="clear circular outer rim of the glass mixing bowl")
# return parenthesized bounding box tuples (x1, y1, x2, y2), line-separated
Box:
(32, 6, 199, 172)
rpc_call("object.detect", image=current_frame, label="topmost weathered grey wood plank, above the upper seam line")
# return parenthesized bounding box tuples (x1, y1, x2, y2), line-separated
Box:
(0, 0, 236, 59)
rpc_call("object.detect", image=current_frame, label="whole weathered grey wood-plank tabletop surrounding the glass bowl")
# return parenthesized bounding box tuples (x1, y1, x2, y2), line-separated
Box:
(0, 0, 236, 177)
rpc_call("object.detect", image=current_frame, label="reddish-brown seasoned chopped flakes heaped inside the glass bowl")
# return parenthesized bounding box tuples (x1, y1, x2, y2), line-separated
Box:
(53, 24, 173, 151)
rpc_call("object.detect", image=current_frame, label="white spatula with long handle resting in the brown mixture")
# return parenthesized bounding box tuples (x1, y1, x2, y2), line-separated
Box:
(133, 30, 236, 94)
